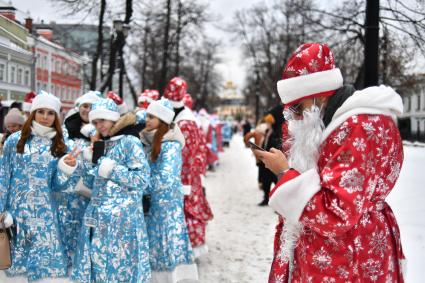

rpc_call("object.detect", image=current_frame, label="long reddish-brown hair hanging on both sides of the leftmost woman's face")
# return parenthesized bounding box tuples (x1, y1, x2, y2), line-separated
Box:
(16, 111, 67, 157)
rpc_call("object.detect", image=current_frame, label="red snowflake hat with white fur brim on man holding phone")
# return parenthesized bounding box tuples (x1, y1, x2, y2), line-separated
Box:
(277, 43, 343, 105)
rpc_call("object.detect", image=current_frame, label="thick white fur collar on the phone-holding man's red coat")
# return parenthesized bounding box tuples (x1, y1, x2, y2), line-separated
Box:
(322, 85, 403, 140)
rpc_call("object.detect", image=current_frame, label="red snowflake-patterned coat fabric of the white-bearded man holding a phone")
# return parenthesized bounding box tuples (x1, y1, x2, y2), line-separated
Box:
(269, 114, 404, 283)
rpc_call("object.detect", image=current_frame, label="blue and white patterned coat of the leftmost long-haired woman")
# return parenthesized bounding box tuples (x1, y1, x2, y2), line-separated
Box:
(0, 132, 72, 282)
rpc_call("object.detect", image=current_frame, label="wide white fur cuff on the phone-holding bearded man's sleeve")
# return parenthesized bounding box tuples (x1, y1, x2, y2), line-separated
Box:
(269, 169, 321, 223)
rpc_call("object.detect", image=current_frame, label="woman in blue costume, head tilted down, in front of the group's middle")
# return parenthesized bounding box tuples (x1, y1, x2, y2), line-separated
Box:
(71, 99, 151, 283)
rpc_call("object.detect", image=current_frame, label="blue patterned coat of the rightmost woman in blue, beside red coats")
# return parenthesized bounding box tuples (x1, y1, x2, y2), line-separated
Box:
(146, 141, 193, 271)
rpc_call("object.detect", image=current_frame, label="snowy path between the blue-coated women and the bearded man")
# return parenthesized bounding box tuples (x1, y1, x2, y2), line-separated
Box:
(198, 135, 277, 283)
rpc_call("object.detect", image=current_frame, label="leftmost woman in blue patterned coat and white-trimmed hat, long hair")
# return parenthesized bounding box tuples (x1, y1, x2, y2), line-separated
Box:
(0, 92, 78, 283)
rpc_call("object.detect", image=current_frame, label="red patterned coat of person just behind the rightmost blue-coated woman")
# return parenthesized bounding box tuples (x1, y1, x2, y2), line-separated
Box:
(177, 120, 213, 247)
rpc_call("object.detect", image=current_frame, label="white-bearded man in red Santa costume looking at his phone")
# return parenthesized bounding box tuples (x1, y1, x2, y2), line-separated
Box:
(255, 43, 404, 283)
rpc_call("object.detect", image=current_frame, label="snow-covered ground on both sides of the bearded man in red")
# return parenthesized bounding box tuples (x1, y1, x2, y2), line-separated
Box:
(198, 136, 425, 283)
